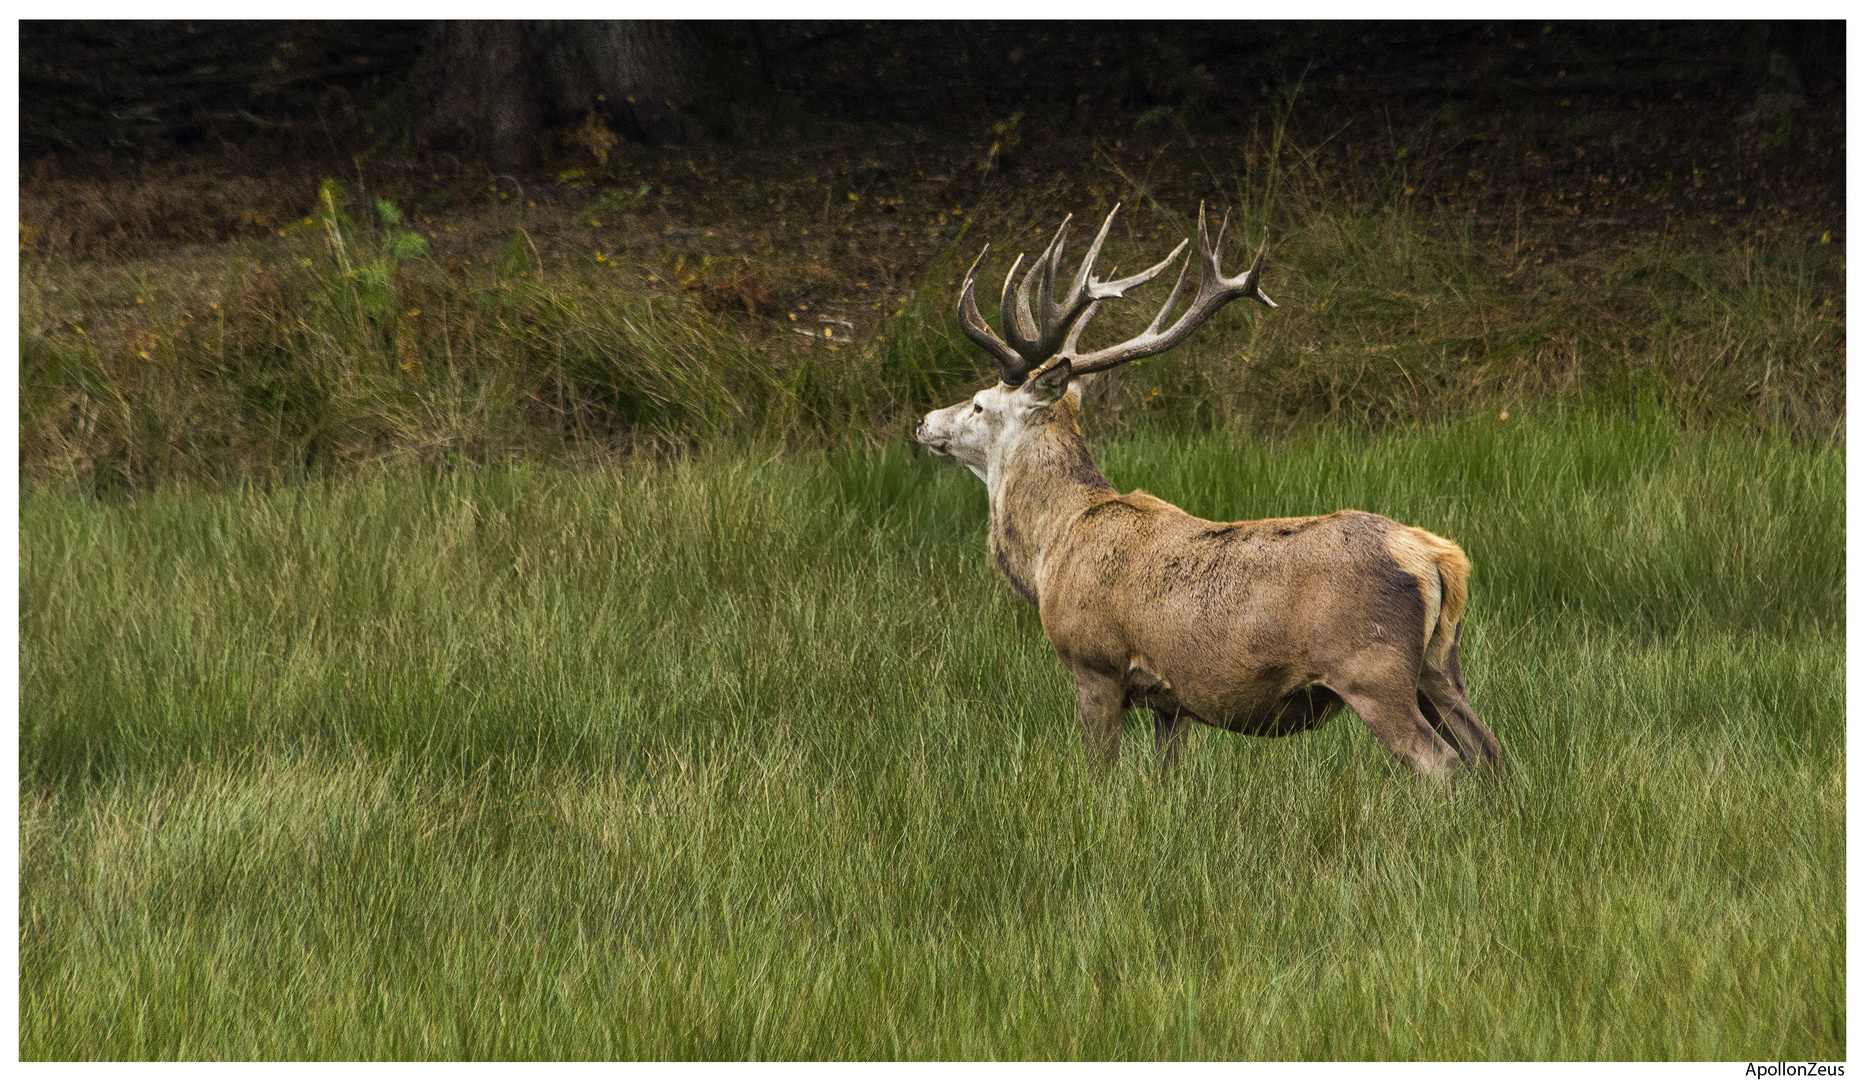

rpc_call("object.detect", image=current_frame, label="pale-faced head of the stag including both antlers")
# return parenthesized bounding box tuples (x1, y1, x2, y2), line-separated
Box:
(914, 203, 1276, 479)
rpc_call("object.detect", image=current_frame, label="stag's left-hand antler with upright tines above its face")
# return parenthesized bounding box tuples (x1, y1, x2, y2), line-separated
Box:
(959, 205, 1186, 386)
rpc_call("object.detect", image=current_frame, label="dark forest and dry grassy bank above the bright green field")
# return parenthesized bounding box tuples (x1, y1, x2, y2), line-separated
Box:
(21, 21, 1846, 487)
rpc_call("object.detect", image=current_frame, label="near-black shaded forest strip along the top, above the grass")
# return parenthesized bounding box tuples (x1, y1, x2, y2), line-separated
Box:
(21, 21, 1844, 164)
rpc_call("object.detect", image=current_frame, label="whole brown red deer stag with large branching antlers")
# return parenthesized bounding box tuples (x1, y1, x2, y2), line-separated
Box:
(916, 207, 1501, 776)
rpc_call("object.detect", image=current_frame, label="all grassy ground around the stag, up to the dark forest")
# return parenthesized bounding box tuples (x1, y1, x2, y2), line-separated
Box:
(19, 78, 1846, 1061)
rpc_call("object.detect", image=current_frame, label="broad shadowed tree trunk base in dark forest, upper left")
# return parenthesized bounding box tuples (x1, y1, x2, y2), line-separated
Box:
(416, 21, 703, 168)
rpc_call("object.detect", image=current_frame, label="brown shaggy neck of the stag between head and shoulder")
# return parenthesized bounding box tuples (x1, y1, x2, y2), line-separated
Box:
(985, 416, 1113, 604)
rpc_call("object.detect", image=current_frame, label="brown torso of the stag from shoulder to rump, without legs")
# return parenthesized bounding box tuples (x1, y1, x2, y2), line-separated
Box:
(1035, 492, 1468, 737)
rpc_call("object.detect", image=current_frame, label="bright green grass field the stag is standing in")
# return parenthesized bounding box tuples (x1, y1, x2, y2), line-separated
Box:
(19, 407, 1846, 1061)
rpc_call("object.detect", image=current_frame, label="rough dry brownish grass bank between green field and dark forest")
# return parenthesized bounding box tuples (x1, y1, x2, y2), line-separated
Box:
(21, 108, 1844, 487)
